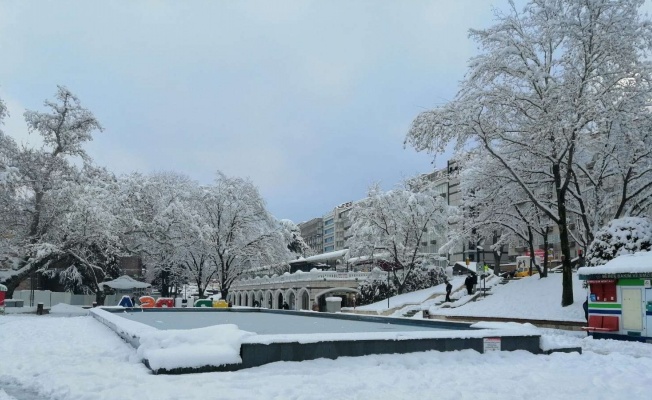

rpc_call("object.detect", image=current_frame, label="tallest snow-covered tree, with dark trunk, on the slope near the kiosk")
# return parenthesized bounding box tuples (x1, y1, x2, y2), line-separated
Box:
(406, 0, 652, 306)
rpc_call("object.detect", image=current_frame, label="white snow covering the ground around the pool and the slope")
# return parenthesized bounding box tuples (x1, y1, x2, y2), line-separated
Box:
(0, 276, 652, 400)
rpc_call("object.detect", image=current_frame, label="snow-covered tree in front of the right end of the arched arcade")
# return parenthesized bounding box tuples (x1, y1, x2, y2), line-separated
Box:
(347, 180, 448, 293)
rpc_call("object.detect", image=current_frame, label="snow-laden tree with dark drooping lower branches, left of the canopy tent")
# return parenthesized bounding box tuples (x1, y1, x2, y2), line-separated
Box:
(28, 165, 125, 304)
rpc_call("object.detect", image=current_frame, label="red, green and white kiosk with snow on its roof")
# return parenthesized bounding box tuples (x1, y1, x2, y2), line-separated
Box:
(577, 252, 652, 343)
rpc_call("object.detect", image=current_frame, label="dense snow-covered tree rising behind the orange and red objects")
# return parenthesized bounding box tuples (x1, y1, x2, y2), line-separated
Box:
(120, 172, 208, 296)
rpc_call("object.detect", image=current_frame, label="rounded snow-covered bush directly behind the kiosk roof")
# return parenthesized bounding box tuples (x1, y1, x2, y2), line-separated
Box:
(586, 217, 652, 266)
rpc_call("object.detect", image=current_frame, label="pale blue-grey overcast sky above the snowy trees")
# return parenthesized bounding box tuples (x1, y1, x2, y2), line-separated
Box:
(0, 0, 652, 223)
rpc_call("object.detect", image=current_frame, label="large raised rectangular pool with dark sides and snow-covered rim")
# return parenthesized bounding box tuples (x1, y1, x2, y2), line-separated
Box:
(91, 308, 541, 374)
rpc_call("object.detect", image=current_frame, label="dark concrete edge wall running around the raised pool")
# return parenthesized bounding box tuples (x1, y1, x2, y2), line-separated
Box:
(91, 308, 581, 374)
